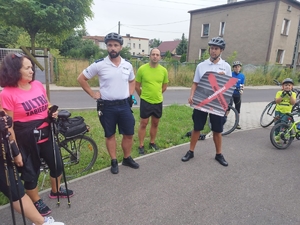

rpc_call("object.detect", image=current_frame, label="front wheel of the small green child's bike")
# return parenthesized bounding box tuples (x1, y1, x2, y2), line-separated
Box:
(270, 123, 294, 149)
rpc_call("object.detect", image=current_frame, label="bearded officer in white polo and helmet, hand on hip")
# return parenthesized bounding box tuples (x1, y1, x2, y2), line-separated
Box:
(77, 33, 139, 174)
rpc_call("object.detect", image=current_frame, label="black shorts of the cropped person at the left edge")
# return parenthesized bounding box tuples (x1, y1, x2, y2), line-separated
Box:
(0, 155, 25, 202)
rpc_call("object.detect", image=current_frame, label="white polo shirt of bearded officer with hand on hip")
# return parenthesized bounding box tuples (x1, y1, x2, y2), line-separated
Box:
(82, 56, 135, 100)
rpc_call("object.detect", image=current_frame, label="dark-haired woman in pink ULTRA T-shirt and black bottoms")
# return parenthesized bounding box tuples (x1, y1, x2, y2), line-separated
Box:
(0, 53, 74, 216)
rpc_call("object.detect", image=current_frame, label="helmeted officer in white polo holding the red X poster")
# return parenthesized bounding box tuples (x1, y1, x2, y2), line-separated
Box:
(181, 37, 232, 166)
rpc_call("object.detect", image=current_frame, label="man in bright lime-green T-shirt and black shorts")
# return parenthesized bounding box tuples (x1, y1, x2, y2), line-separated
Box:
(135, 48, 169, 155)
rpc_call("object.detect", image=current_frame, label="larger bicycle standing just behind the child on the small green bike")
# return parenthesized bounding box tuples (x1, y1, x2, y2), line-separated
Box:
(260, 80, 300, 128)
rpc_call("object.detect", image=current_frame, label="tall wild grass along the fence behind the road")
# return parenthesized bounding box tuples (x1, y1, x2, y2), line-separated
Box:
(55, 58, 300, 87)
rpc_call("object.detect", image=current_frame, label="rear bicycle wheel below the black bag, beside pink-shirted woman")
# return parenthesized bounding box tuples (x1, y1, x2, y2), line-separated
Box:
(60, 135, 98, 178)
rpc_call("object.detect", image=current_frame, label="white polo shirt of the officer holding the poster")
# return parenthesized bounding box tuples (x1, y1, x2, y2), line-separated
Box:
(193, 58, 232, 83)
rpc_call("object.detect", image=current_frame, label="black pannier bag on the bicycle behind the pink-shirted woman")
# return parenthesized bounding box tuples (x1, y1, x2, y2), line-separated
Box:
(58, 116, 87, 138)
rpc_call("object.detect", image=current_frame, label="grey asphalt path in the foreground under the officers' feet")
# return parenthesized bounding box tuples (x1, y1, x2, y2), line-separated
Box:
(0, 128, 300, 225)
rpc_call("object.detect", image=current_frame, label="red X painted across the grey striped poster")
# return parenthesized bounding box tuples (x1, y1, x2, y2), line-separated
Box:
(197, 74, 237, 111)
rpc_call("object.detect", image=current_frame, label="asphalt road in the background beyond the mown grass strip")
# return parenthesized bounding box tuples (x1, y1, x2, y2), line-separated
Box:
(50, 89, 279, 109)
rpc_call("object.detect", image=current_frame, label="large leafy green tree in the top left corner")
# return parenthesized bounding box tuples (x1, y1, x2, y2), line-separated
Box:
(0, 0, 93, 52)
